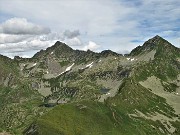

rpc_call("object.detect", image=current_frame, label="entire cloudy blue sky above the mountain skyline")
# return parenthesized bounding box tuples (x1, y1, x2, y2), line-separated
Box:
(0, 0, 180, 57)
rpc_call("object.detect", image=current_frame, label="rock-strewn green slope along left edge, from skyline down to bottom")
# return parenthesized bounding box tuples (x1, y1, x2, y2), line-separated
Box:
(0, 56, 48, 134)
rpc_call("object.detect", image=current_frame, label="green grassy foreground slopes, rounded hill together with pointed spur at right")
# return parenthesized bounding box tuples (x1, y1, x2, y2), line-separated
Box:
(26, 79, 180, 135)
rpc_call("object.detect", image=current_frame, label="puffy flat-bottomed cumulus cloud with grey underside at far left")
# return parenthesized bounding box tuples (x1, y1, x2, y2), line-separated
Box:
(0, 18, 50, 35)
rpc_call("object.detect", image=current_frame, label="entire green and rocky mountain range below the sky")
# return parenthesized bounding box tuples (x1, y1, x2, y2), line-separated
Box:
(0, 35, 180, 135)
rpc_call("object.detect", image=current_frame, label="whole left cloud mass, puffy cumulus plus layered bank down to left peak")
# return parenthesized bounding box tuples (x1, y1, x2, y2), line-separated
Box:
(0, 18, 82, 57)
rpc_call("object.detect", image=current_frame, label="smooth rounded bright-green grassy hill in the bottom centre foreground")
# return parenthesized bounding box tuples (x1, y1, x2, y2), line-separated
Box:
(32, 101, 172, 135)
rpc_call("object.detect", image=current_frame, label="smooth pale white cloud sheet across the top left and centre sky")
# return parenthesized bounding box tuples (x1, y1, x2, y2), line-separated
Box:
(0, 0, 126, 35)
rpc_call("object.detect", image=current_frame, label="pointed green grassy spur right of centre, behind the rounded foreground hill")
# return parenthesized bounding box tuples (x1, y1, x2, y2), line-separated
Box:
(106, 79, 176, 117)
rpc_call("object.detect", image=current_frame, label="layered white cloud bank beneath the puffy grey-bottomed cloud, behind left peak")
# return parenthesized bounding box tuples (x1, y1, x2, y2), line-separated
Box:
(0, 22, 82, 58)
